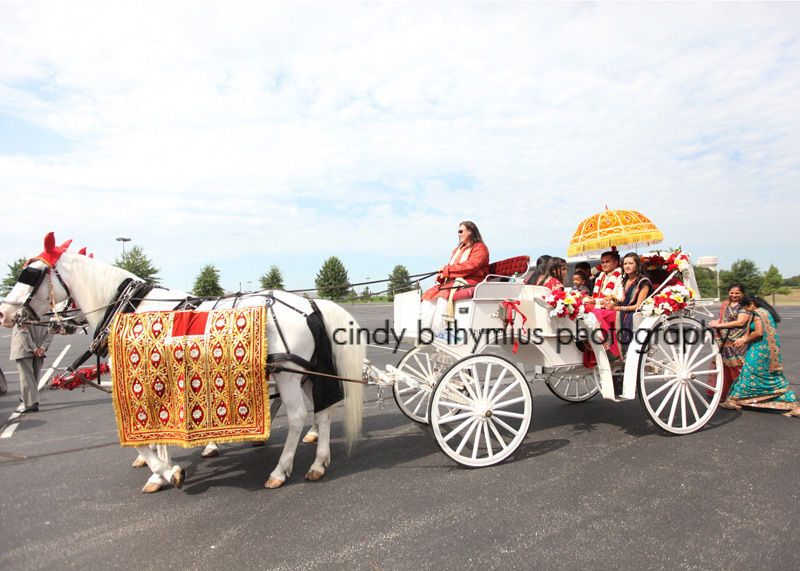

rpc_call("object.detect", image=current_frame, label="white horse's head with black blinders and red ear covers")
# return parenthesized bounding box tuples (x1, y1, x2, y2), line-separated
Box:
(0, 232, 72, 327)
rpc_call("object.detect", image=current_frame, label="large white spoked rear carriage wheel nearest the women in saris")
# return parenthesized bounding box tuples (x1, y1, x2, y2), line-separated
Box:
(637, 317, 722, 434)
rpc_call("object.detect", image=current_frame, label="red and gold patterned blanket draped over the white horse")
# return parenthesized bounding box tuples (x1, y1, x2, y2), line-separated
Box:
(109, 306, 270, 447)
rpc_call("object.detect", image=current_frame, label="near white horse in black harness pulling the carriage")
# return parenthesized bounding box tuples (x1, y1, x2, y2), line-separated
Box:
(0, 232, 365, 492)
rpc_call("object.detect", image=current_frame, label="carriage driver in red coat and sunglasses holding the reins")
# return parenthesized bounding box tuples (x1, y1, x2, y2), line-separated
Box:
(421, 221, 489, 330)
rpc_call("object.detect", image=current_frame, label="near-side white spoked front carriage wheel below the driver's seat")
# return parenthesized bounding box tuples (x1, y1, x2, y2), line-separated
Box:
(430, 355, 533, 468)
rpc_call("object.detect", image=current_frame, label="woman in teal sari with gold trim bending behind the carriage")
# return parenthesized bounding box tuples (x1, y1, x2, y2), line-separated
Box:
(720, 295, 800, 416)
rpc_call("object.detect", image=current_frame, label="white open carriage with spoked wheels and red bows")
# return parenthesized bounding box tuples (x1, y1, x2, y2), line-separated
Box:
(372, 252, 722, 467)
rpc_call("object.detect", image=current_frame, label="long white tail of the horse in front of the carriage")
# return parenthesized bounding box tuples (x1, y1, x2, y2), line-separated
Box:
(316, 300, 367, 452)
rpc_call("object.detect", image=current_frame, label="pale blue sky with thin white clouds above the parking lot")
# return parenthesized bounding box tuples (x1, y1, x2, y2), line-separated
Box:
(0, 2, 800, 290)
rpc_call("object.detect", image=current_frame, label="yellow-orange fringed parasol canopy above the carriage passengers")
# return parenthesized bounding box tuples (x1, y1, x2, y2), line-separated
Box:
(567, 209, 664, 257)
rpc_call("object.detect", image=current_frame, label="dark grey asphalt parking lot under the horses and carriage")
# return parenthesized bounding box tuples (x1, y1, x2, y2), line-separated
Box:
(0, 305, 800, 570)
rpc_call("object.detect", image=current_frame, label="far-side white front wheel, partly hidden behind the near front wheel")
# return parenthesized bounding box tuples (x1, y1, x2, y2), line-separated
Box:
(392, 345, 456, 424)
